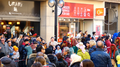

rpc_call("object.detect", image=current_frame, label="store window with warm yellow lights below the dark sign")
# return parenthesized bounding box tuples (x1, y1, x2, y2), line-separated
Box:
(0, 21, 40, 37)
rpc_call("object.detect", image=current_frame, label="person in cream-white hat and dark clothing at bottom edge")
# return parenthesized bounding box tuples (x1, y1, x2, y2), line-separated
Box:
(70, 54, 81, 67)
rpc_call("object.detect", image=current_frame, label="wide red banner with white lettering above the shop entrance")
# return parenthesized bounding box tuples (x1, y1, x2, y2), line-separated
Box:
(59, 2, 93, 19)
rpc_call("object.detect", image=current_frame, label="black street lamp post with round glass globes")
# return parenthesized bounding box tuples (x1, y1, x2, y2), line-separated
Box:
(48, 0, 64, 41)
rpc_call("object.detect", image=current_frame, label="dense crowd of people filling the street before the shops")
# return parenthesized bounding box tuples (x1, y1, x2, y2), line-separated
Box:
(0, 30, 120, 67)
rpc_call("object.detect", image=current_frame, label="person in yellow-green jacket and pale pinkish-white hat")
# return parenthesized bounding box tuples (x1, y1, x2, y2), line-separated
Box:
(76, 42, 90, 61)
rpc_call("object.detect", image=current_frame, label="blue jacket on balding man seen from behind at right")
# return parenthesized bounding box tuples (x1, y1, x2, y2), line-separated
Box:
(91, 48, 112, 67)
